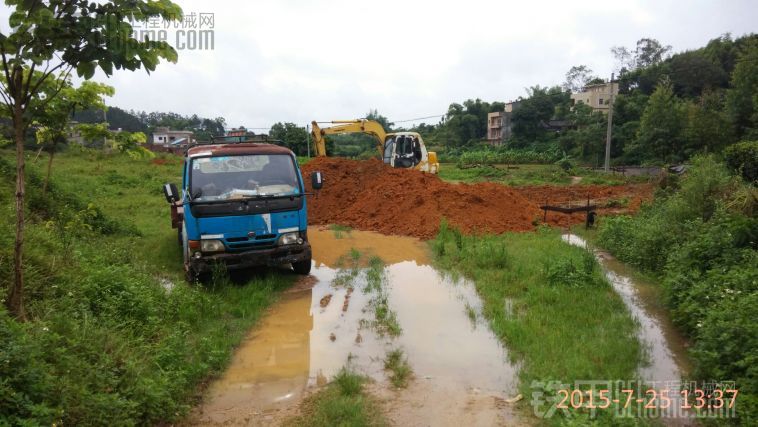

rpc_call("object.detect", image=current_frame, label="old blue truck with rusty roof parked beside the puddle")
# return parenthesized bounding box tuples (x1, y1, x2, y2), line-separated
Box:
(163, 142, 323, 281)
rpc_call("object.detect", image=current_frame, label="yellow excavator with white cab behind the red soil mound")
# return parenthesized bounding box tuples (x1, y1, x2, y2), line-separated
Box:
(311, 119, 440, 174)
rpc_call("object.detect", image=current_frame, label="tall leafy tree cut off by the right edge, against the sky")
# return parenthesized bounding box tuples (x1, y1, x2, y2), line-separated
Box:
(726, 40, 758, 139)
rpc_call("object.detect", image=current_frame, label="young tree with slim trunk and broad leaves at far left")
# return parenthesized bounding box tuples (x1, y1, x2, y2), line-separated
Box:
(0, 0, 182, 320)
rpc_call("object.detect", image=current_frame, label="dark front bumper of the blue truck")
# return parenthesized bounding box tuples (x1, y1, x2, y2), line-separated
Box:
(190, 242, 311, 273)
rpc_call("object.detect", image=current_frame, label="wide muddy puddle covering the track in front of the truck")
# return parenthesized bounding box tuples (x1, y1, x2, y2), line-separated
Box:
(193, 229, 517, 425)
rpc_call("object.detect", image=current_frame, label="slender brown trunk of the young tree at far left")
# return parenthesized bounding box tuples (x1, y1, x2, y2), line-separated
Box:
(7, 103, 26, 320)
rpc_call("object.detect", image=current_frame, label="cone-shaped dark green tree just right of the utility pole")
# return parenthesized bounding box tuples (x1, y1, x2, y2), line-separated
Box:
(634, 80, 684, 161)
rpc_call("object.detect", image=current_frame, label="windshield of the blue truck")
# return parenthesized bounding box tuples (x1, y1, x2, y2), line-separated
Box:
(190, 154, 300, 201)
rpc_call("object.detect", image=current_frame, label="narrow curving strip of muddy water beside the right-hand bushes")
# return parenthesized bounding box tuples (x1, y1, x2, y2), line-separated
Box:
(562, 234, 692, 425)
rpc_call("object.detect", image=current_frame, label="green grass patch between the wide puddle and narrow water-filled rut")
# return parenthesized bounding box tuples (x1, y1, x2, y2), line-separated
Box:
(431, 223, 644, 422)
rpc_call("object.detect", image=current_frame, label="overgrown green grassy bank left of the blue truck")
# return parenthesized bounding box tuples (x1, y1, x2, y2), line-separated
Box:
(0, 149, 293, 425)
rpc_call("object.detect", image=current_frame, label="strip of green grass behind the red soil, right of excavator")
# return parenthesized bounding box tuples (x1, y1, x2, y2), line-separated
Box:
(439, 163, 640, 186)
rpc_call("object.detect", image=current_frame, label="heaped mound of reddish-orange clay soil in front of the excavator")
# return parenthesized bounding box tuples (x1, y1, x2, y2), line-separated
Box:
(303, 157, 652, 239)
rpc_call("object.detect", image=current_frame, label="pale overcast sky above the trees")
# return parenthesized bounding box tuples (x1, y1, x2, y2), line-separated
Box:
(2, 0, 758, 128)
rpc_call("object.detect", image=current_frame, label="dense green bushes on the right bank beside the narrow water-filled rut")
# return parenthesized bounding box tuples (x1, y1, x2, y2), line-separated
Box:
(598, 157, 758, 425)
